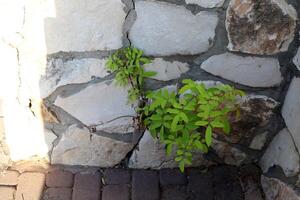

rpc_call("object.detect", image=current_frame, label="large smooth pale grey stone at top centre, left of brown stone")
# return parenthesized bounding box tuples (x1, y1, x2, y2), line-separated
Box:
(129, 1, 218, 56)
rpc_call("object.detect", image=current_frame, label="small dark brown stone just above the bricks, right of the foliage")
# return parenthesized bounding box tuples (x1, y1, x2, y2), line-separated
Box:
(212, 139, 247, 166)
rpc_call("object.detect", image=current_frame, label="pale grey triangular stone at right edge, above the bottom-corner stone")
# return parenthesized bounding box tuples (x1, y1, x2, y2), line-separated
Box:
(259, 129, 299, 177)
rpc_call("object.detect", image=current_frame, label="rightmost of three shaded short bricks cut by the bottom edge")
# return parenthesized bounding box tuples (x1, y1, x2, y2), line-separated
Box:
(161, 185, 188, 200)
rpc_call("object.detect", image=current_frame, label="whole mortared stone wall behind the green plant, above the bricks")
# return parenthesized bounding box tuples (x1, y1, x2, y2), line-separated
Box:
(0, 0, 300, 199)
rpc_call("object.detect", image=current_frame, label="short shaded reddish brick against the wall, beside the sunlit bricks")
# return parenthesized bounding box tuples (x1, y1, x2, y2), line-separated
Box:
(46, 170, 73, 187)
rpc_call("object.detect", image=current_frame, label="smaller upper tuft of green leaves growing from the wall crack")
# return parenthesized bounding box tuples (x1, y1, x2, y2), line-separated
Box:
(106, 47, 156, 103)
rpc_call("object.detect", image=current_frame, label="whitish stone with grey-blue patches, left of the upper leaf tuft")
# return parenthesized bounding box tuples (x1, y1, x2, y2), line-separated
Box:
(40, 58, 108, 98)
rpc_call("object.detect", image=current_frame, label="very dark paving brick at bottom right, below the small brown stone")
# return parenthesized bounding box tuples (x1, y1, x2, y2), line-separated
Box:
(213, 166, 244, 200)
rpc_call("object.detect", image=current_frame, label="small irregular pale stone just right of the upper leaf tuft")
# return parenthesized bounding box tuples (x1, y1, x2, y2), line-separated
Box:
(144, 58, 189, 81)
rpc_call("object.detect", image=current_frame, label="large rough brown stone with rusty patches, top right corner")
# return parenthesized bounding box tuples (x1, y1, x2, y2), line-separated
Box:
(226, 0, 297, 55)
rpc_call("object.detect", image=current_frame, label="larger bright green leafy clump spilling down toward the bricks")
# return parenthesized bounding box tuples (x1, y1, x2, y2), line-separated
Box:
(143, 80, 244, 171)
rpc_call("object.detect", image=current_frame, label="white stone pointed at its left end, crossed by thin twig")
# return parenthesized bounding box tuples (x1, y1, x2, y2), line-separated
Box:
(55, 81, 135, 133)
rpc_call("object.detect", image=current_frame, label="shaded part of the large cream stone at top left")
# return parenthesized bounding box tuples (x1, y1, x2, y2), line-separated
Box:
(45, 0, 126, 54)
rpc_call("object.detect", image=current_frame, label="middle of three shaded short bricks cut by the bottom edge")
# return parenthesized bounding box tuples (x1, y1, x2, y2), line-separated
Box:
(102, 185, 130, 200)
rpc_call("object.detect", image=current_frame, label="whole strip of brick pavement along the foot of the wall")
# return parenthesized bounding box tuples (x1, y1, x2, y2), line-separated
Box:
(0, 166, 259, 200)
